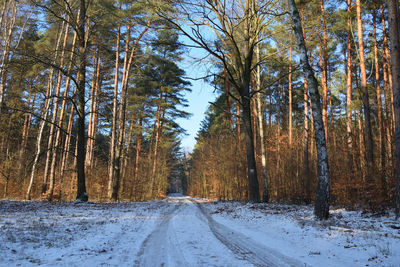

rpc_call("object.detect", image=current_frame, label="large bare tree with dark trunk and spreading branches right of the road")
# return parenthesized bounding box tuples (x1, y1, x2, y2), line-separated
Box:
(157, 0, 278, 202)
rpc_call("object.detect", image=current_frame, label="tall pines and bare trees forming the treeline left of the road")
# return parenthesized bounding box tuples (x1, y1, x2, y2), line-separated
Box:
(0, 0, 190, 201)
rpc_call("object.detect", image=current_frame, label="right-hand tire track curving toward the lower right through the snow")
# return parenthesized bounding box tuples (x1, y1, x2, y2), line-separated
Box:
(192, 200, 304, 267)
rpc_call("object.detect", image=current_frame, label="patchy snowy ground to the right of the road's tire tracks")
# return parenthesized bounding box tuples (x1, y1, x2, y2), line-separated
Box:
(203, 202, 400, 266)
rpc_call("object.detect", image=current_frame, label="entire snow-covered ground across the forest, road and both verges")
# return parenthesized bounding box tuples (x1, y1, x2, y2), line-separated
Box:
(0, 195, 400, 267)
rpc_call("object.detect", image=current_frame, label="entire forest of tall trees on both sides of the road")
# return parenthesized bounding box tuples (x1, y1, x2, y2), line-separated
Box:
(0, 0, 400, 219)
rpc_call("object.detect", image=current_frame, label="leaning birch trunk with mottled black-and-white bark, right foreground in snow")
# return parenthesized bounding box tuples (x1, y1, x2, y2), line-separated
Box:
(288, 0, 330, 219)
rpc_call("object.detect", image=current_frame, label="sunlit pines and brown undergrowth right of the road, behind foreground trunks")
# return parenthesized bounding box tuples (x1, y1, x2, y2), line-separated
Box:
(188, 0, 398, 218)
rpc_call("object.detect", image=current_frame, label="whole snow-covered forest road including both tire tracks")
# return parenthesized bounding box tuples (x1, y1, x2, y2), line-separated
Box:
(136, 197, 298, 267)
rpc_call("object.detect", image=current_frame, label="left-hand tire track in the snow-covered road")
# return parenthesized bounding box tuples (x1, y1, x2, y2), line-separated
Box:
(135, 202, 189, 267)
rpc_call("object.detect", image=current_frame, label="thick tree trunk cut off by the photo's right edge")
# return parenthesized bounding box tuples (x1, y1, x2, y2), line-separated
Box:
(387, 0, 400, 218)
